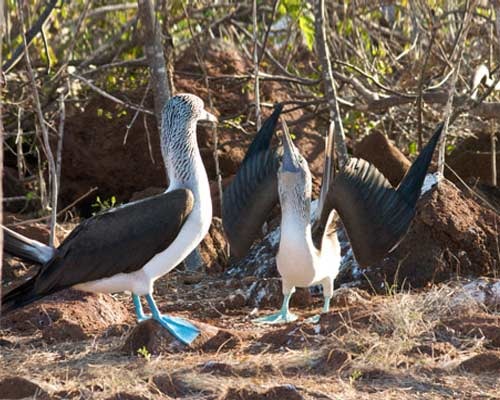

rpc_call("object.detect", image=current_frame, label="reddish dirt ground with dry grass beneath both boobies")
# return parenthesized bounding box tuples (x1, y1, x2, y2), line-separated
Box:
(0, 252, 500, 399)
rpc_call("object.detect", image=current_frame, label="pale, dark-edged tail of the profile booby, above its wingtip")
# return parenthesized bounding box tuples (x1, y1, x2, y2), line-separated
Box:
(3, 227, 57, 264)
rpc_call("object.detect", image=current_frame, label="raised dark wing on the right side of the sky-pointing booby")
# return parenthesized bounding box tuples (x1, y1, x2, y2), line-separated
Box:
(323, 125, 443, 266)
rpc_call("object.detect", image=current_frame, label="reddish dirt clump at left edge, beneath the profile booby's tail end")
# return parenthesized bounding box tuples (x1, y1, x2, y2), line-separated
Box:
(2, 289, 130, 343)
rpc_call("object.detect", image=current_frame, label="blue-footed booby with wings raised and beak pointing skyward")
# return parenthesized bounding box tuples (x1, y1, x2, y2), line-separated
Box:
(223, 107, 442, 323)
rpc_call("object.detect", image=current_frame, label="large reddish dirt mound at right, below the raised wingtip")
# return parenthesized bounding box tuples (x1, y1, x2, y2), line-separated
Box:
(364, 179, 500, 292)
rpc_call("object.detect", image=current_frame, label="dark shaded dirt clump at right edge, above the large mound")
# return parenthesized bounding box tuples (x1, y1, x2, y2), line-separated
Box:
(445, 132, 500, 185)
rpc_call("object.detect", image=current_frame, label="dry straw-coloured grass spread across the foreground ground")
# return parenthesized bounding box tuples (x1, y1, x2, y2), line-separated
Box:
(0, 285, 500, 399)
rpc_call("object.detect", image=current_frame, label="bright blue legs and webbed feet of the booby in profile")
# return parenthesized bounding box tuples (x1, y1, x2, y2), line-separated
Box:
(132, 295, 200, 345)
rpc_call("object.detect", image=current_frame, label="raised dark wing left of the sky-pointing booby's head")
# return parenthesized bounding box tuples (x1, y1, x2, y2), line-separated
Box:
(222, 105, 282, 257)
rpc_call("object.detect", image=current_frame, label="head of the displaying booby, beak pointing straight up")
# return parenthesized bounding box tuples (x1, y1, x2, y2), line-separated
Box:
(278, 121, 312, 216)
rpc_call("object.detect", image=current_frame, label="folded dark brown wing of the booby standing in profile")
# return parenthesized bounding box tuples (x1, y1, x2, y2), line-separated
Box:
(16, 189, 193, 295)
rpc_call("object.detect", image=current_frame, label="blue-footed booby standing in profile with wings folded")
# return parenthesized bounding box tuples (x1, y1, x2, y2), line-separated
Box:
(2, 94, 217, 344)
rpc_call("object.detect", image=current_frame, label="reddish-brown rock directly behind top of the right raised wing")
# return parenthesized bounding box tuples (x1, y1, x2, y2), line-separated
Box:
(354, 131, 411, 186)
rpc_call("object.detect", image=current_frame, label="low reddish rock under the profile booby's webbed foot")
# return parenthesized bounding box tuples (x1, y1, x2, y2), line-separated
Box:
(122, 319, 237, 355)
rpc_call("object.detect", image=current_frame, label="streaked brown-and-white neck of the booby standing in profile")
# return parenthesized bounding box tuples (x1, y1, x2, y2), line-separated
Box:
(161, 121, 211, 202)
